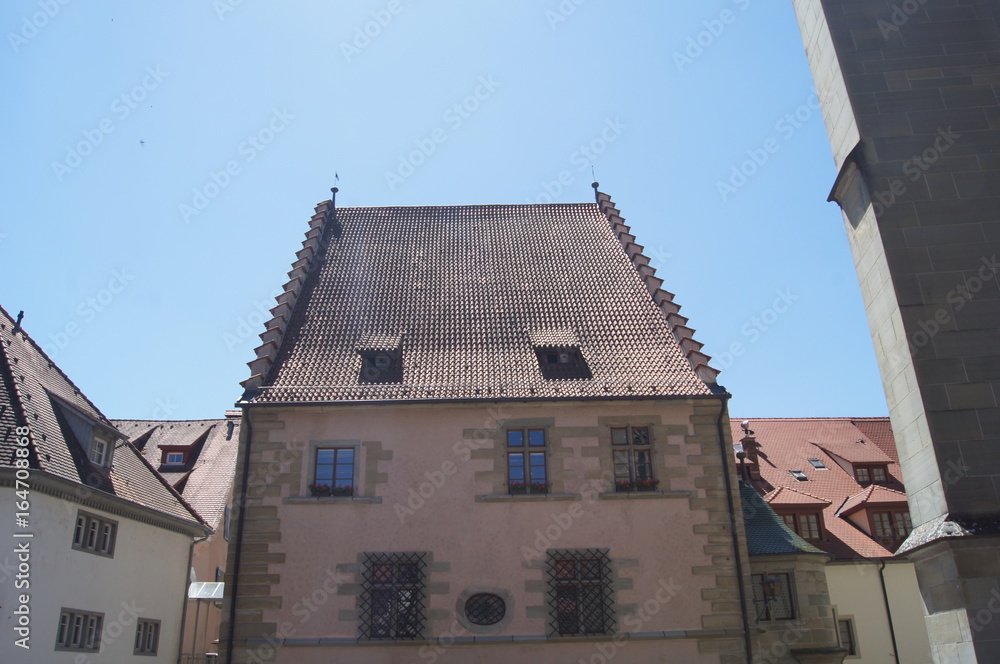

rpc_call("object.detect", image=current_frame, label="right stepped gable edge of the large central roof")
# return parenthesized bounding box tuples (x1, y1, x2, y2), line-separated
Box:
(594, 189, 720, 385)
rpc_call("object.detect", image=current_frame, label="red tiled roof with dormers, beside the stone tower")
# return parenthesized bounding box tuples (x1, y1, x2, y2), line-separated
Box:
(731, 417, 905, 559)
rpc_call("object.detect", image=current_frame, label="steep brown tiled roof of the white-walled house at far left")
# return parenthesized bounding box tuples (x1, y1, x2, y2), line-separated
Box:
(0, 307, 206, 522)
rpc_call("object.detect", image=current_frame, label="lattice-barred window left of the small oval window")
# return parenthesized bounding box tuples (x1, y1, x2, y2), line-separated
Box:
(359, 553, 427, 641)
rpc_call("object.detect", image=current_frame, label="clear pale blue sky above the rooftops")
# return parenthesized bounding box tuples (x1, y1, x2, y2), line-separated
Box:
(0, 0, 886, 419)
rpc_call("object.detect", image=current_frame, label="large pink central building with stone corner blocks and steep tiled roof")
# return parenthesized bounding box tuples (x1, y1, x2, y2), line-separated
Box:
(217, 185, 843, 664)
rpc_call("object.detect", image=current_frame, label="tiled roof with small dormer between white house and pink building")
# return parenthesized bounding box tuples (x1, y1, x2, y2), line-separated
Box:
(113, 411, 240, 529)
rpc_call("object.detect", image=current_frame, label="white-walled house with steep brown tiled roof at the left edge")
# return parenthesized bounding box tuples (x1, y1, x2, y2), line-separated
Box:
(0, 308, 212, 664)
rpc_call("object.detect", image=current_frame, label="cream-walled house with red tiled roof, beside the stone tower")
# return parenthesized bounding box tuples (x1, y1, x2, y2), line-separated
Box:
(731, 417, 930, 664)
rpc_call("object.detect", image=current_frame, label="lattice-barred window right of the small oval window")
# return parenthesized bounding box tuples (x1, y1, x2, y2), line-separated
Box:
(547, 549, 615, 636)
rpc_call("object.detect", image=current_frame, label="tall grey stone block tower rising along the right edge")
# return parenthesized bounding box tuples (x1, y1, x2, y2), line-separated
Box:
(794, 0, 1000, 663)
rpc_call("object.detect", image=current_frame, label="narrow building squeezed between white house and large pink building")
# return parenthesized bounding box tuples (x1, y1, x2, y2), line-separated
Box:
(112, 410, 240, 664)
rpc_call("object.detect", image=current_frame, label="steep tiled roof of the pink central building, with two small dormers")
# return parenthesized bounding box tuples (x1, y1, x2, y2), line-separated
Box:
(244, 194, 715, 402)
